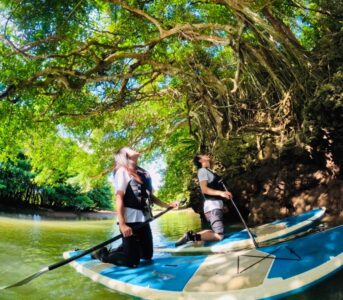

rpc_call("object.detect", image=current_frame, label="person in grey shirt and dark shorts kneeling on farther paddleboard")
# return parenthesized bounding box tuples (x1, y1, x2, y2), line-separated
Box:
(175, 155, 232, 247)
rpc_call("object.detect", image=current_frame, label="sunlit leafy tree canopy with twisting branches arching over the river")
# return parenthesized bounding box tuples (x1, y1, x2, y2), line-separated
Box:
(0, 0, 343, 203)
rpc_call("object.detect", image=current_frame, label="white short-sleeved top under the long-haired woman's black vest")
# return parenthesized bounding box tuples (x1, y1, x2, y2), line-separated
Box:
(113, 167, 149, 223)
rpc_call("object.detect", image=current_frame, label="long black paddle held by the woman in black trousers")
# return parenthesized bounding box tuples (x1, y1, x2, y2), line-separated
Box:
(0, 199, 186, 290)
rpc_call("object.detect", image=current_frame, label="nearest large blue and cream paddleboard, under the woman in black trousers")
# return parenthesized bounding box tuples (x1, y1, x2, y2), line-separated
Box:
(64, 226, 343, 300)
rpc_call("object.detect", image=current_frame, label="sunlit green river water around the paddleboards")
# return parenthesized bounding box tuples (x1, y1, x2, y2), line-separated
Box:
(0, 211, 343, 300)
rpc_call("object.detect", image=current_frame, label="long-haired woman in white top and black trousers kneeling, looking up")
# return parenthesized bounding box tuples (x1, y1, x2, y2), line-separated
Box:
(92, 147, 178, 268)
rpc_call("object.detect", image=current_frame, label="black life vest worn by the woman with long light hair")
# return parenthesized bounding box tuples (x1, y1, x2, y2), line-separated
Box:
(124, 168, 152, 212)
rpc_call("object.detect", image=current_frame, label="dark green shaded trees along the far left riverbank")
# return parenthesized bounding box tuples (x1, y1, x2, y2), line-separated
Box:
(0, 154, 113, 210)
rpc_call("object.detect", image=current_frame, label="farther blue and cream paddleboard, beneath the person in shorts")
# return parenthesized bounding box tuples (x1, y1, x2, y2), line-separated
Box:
(155, 207, 326, 254)
